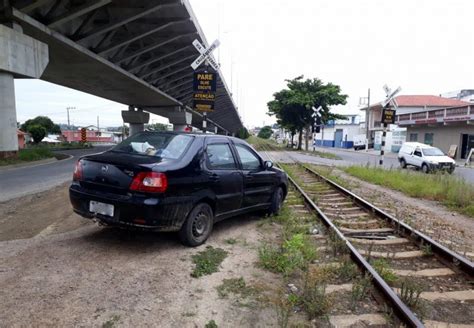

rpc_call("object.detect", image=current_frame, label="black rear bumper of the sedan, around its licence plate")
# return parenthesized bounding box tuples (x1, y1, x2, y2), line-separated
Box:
(69, 183, 193, 231)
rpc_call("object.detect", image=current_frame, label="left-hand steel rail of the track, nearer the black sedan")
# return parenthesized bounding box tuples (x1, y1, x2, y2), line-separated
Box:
(265, 151, 424, 327)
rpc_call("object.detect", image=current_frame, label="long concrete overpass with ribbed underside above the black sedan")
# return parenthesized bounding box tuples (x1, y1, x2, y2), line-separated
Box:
(0, 0, 242, 158)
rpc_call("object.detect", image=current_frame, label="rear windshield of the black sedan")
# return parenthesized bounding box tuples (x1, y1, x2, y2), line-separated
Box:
(112, 132, 194, 159)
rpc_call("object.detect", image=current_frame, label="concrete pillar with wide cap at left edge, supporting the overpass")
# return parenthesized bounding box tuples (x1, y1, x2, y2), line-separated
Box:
(0, 24, 49, 158)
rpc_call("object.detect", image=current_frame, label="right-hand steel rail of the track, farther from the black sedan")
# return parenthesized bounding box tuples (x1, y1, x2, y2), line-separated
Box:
(302, 165, 474, 276)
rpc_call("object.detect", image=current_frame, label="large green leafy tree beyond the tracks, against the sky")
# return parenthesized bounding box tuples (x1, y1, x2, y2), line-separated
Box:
(267, 76, 347, 149)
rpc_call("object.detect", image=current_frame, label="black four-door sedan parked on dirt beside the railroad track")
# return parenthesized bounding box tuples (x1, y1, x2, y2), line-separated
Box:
(69, 132, 288, 246)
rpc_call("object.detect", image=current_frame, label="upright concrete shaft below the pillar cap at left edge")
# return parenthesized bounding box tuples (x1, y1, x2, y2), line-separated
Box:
(0, 72, 18, 158)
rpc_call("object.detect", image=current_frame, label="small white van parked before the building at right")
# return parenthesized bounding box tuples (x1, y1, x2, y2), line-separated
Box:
(398, 142, 456, 173)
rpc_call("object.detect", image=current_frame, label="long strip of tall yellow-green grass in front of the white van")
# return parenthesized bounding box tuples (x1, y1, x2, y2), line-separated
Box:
(344, 166, 474, 218)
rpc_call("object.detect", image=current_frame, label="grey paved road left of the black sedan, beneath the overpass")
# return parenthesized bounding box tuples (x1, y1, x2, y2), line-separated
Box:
(0, 146, 110, 202)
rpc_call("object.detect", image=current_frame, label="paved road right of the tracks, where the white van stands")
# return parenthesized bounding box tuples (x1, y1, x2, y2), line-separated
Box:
(262, 148, 474, 184)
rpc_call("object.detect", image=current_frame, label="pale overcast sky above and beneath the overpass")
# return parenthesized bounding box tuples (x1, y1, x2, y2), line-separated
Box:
(15, 0, 474, 127)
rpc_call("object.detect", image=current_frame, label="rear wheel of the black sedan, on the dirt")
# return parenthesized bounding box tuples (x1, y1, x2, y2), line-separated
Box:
(179, 203, 214, 247)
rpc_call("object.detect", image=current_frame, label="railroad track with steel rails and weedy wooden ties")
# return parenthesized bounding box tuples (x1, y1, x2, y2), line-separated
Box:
(260, 146, 474, 328)
